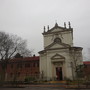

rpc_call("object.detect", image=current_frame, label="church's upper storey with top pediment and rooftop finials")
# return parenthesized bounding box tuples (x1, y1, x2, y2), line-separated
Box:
(42, 22, 73, 48)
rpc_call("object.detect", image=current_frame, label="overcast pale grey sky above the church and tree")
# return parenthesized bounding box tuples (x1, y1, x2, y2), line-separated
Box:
(0, 0, 90, 58)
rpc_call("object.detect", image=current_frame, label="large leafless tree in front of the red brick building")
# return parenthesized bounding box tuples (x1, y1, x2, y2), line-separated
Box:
(0, 32, 31, 81)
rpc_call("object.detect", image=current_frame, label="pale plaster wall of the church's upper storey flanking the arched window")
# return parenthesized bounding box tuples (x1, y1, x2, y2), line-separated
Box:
(44, 31, 73, 48)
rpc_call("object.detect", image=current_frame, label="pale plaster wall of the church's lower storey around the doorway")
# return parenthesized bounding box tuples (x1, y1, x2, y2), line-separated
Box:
(40, 50, 72, 80)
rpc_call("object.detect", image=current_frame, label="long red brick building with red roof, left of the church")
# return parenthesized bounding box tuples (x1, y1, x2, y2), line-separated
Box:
(0, 56, 39, 81)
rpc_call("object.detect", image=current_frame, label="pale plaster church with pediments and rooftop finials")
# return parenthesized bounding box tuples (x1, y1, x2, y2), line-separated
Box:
(39, 22, 83, 80)
